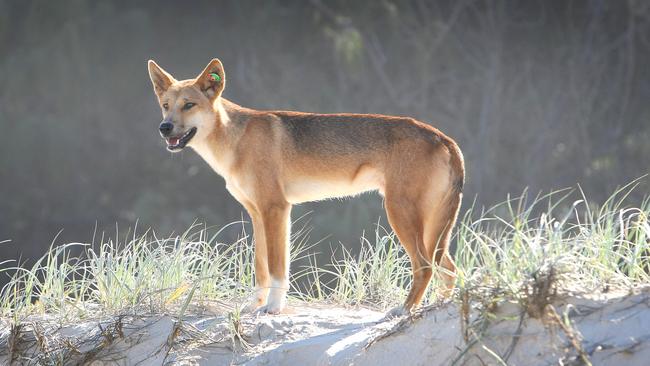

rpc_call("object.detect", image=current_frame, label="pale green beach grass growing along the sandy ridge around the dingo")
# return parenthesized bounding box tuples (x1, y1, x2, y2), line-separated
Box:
(0, 182, 650, 330)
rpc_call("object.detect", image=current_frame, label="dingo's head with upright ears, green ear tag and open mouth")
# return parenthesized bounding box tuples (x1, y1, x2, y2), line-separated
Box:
(149, 59, 226, 152)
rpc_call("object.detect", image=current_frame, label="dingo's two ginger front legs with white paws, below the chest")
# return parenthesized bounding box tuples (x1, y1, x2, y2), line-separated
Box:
(259, 202, 291, 314)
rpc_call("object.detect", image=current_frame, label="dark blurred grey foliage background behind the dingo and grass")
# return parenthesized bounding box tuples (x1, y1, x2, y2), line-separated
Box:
(0, 0, 650, 266)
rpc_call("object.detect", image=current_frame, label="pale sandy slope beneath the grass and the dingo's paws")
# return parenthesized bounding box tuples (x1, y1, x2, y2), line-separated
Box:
(0, 289, 650, 365)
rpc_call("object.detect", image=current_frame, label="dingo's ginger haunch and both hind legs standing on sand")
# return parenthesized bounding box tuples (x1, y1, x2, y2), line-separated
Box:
(385, 142, 463, 311)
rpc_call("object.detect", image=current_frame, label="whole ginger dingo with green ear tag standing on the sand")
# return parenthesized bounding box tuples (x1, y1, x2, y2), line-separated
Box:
(149, 59, 464, 313)
